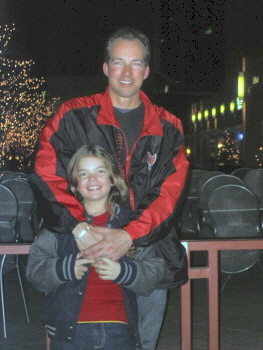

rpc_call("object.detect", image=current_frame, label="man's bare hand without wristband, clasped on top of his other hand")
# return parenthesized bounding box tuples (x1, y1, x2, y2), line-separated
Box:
(83, 226, 132, 261)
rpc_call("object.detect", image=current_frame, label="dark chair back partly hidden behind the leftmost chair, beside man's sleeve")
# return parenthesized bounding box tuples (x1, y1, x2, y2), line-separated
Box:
(2, 178, 38, 242)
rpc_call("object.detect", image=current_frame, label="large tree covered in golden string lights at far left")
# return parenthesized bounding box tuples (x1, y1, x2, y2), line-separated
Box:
(0, 24, 58, 172)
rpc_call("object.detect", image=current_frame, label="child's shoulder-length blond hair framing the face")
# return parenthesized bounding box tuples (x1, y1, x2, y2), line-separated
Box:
(67, 145, 128, 212)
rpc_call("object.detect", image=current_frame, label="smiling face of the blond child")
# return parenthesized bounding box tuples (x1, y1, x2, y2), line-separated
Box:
(78, 156, 112, 208)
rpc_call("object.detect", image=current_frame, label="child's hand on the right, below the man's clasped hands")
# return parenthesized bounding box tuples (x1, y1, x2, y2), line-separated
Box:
(92, 256, 121, 281)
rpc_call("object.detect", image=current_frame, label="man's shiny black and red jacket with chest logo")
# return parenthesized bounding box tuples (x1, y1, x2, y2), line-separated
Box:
(30, 89, 189, 246)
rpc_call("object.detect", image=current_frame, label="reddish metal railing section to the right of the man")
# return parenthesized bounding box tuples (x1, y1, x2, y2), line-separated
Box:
(181, 239, 263, 350)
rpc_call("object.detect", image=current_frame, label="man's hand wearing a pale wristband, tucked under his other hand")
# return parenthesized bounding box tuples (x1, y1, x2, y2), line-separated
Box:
(72, 222, 103, 250)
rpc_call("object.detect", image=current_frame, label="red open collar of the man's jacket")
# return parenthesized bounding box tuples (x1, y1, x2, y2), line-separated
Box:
(97, 88, 163, 137)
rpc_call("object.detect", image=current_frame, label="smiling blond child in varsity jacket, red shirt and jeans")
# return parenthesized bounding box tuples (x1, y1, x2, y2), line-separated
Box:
(27, 145, 164, 350)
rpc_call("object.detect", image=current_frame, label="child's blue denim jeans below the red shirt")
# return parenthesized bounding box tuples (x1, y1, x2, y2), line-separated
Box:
(50, 322, 135, 350)
